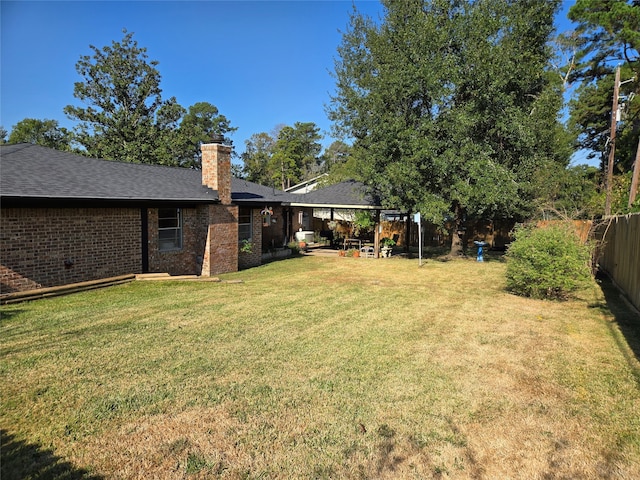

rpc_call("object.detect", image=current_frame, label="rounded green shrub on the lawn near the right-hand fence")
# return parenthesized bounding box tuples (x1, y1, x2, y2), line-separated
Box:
(507, 223, 591, 299)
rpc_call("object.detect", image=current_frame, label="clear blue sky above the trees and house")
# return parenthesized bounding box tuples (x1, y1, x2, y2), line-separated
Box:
(0, 0, 574, 163)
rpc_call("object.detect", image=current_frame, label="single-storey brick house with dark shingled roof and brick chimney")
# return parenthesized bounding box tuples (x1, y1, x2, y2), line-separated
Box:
(0, 143, 298, 293)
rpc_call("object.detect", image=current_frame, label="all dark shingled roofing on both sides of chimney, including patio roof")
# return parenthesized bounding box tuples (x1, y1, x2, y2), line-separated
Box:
(0, 143, 380, 208)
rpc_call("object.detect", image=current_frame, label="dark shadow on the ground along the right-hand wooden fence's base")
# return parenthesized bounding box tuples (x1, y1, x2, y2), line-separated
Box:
(592, 273, 640, 385)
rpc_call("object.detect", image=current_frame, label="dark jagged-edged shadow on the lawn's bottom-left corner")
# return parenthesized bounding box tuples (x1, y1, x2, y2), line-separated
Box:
(0, 430, 102, 480)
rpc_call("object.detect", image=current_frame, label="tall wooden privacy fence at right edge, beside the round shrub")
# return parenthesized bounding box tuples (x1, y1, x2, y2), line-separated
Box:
(597, 213, 640, 309)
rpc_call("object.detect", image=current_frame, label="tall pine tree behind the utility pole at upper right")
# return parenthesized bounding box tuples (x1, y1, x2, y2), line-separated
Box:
(567, 0, 640, 172)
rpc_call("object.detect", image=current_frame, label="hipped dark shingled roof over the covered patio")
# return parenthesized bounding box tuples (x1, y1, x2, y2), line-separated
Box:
(291, 180, 382, 210)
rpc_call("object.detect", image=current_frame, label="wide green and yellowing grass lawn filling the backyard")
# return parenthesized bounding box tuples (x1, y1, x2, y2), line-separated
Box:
(0, 256, 640, 480)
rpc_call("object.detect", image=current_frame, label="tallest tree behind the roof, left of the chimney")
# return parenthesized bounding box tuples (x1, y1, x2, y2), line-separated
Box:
(64, 31, 172, 163)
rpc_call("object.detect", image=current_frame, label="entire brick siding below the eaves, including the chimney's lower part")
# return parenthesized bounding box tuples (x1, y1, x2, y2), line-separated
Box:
(0, 200, 262, 293)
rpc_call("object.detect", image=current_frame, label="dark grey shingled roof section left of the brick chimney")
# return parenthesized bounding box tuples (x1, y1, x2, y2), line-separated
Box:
(0, 143, 218, 203)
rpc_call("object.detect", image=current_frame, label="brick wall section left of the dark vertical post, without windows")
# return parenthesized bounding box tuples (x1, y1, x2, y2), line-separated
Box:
(0, 208, 142, 293)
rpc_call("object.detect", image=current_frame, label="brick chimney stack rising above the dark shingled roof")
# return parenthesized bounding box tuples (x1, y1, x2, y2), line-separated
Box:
(200, 135, 231, 205)
